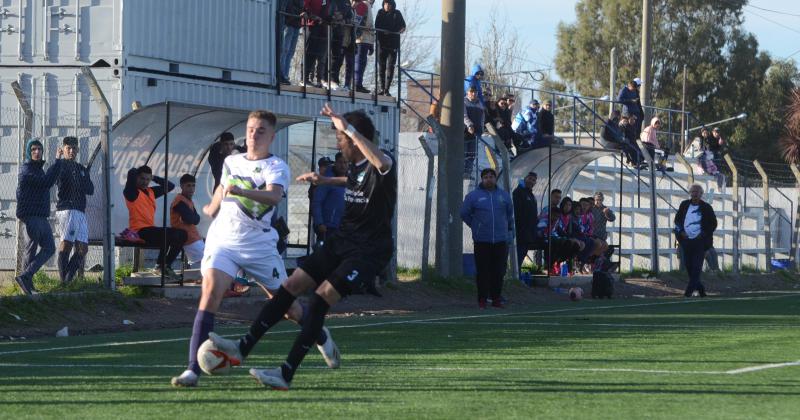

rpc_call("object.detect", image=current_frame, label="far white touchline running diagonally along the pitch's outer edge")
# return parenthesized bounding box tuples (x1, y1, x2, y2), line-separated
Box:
(0, 293, 800, 356)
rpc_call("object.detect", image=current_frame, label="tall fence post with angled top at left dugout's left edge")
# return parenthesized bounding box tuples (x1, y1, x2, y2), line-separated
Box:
(81, 67, 117, 290)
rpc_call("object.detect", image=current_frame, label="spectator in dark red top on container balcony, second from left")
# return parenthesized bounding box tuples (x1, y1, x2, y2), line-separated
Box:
(303, 0, 330, 87)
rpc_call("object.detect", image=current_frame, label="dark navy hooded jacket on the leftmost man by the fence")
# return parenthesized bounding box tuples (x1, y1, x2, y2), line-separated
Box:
(16, 139, 62, 219)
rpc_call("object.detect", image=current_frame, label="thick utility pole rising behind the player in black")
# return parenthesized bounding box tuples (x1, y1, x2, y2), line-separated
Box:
(436, 0, 467, 277)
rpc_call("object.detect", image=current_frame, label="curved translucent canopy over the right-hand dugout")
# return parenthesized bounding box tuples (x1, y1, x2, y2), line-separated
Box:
(511, 145, 620, 206)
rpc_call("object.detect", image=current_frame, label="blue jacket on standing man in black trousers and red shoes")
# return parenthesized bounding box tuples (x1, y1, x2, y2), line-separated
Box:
(461, 184, 514, 243)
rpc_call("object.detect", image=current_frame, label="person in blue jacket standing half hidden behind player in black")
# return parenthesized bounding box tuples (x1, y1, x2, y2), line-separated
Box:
(311, 152, 347, 241)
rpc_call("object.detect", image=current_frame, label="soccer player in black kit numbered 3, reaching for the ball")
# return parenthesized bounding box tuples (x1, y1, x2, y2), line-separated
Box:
(209, 104, 397, 390)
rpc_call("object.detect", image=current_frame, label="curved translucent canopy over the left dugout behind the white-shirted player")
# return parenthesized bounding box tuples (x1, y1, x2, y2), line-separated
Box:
(111, 101, 311, 233)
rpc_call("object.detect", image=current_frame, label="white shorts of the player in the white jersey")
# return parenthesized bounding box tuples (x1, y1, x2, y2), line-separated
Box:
(200, 241, 287, 290)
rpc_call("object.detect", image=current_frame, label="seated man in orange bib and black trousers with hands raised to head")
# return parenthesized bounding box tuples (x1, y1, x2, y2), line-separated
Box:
(122, 165, 186, 279)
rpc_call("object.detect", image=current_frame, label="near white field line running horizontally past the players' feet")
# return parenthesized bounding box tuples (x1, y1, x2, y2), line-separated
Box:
(0, 363, 728, 375)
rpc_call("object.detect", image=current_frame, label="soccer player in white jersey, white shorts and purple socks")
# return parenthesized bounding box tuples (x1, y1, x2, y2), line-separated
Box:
(172, 111, 339, 387)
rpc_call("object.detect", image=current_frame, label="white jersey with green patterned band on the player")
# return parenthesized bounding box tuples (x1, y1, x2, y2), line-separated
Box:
(207, 153, 290, 243)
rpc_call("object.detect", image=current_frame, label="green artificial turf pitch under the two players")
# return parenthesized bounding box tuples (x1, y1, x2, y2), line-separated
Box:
(0, 294, 800, 419)
